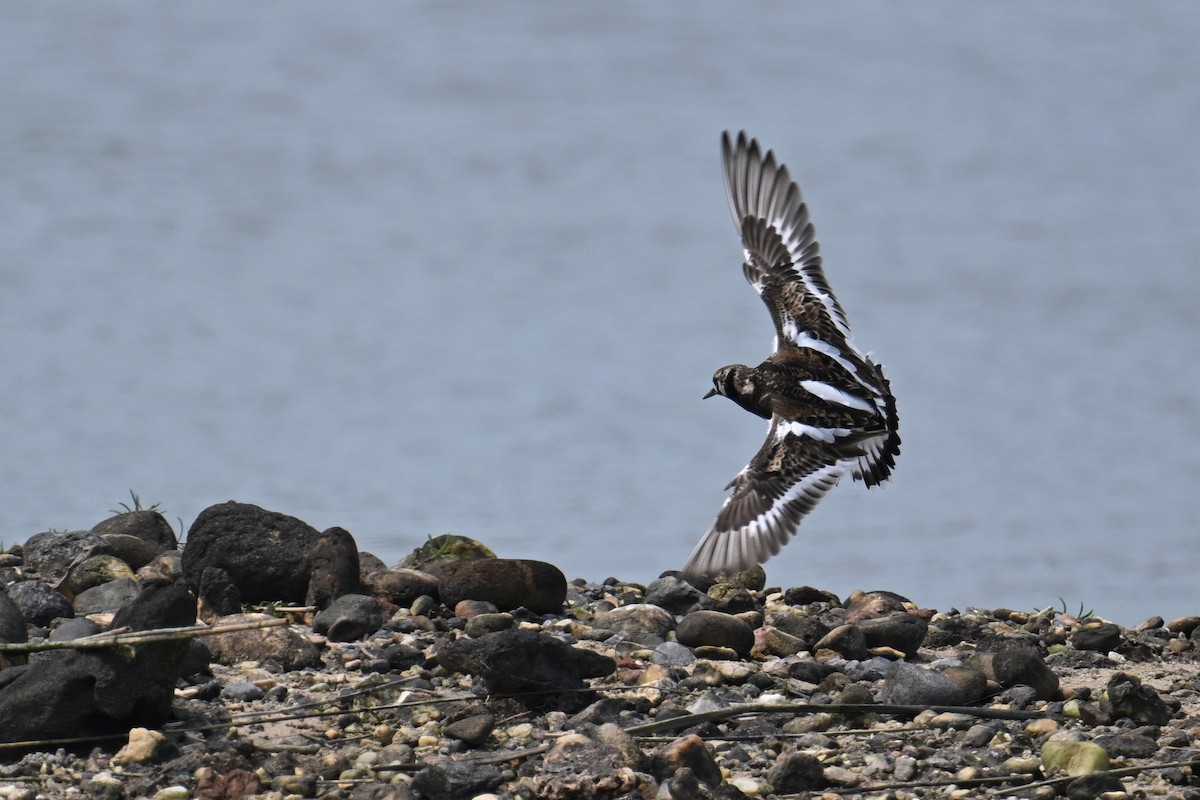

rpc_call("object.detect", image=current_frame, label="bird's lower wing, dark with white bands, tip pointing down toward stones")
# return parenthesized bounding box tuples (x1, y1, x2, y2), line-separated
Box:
(683, 416, 853, 578)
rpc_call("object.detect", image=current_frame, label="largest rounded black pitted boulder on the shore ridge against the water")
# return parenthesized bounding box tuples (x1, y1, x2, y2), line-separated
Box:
(177, 500, 320, 602)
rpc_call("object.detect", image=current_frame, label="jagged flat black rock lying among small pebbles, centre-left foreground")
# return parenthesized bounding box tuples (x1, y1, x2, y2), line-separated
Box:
(437, 630, 617, 708)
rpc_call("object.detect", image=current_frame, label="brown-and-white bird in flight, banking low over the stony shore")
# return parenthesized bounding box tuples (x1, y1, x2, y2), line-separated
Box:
(680, 131, 900, 582)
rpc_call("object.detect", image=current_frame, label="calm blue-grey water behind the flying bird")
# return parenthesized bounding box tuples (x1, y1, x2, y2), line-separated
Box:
(0, 2, 1200, 624)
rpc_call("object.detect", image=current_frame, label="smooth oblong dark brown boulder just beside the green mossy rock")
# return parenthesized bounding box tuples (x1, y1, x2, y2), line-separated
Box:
(438, 559, 566, 614)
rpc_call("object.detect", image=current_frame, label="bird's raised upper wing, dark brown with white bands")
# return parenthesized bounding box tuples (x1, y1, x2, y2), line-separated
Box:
(721, 132, 858, 355)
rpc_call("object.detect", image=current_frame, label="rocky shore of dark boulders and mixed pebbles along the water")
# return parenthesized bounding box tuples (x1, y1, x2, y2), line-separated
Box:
(0, 503, 1200, 800)
